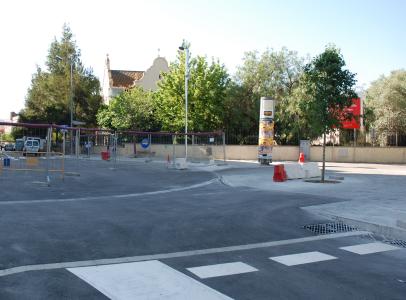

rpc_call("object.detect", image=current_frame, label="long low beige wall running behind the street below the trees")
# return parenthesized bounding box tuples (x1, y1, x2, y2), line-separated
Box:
(92, 144, 406, 164)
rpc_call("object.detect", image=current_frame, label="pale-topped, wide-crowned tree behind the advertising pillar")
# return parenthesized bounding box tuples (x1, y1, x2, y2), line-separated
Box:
(227, 48, 305, 144)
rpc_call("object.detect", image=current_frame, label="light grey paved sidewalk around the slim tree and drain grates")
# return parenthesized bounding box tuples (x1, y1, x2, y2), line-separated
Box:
(217, 162, 406, 240)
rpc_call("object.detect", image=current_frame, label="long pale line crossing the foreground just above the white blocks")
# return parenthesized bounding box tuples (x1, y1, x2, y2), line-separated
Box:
(0, 231, 371, 277)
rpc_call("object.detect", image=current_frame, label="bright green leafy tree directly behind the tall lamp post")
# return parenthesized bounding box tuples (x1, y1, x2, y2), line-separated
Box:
(156, 49, 230, 131)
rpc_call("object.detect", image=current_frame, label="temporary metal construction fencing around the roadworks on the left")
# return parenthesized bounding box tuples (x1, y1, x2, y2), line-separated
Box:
(0, 122, 226, 183)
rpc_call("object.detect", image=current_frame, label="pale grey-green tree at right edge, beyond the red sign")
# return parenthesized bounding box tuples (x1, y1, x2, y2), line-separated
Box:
(366, 70, 406, 145)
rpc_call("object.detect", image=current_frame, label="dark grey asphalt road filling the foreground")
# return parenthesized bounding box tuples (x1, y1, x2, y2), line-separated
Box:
(0, 162, 406, 299)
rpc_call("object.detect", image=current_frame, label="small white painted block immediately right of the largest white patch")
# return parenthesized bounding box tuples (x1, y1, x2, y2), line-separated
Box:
(187, 262, 258, 278)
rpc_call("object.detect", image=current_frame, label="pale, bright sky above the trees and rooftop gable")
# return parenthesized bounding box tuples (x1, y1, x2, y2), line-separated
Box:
(0, 0, 406, 119)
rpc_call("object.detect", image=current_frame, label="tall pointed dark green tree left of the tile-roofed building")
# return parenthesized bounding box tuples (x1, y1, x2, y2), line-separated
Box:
(20, 24, 102, 126)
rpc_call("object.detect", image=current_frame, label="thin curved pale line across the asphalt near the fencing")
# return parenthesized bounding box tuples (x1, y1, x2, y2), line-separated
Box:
(0, 178, 219, 205)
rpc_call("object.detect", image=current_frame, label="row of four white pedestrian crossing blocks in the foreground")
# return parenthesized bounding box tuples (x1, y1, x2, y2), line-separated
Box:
(67, 242, 400, 300)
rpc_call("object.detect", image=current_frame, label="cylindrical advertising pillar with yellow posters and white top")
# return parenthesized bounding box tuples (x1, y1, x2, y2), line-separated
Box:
(258, 97, 275, 165)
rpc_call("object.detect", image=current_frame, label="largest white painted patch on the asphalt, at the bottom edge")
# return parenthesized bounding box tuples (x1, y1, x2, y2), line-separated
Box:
(68, 260, 232, 300)
